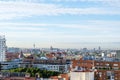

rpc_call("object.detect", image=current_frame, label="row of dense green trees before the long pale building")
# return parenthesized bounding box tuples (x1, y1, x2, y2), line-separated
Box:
(9, 68, 60, 78)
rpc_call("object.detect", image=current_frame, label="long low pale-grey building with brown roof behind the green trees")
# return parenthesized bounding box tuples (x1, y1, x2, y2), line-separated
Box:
(20, 59, 69, 73)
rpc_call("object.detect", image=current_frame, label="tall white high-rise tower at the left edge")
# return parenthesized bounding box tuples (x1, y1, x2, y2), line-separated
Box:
(0, 36, 6, 62)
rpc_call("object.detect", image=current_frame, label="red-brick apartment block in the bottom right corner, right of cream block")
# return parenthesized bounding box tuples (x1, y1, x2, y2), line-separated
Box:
(95, 61, 120, 80)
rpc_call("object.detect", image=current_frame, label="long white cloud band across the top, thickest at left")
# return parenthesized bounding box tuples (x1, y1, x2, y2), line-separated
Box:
(0, 2, 120, 20)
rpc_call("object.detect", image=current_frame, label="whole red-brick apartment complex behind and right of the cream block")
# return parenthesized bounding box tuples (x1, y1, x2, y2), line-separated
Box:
(71, 59, 120, 80)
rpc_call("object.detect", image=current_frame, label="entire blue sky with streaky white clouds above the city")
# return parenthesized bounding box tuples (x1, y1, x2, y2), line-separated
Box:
(0, 0, 120, 49)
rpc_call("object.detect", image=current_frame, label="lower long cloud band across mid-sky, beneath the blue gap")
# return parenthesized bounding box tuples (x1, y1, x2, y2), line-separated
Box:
(0, 20, 120, 33)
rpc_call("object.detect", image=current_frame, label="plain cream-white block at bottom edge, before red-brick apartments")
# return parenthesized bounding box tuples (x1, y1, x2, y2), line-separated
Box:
(70, 71, 94, 80)
